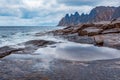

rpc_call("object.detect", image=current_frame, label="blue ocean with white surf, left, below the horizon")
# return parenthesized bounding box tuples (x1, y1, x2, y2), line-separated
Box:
(0, 26, 61, 47)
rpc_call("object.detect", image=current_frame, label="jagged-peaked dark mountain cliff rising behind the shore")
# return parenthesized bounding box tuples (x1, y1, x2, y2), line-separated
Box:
(58, 6, 120, 26)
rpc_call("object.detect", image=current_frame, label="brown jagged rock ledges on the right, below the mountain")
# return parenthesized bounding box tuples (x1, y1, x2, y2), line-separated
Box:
(50, 20, 120, 49)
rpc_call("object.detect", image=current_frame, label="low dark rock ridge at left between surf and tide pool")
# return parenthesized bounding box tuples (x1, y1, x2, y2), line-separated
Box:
(0, 40, 56, 58)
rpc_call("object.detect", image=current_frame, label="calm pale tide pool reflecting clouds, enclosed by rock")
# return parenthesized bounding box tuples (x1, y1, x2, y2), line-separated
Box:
(35, 42, 120, 61)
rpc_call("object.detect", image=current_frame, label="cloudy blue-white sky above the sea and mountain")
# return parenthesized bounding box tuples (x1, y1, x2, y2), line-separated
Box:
(0, 0, 120, 26)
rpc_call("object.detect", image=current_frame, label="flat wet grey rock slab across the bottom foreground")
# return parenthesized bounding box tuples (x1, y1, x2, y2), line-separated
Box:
(0, 59, 120, 80)
